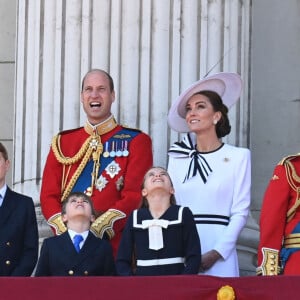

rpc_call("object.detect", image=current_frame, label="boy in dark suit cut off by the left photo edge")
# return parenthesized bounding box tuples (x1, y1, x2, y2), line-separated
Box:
(0, 143, 39, 276)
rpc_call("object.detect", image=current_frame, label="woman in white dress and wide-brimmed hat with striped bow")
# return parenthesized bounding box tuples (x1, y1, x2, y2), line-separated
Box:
(168, 73, 251, 277)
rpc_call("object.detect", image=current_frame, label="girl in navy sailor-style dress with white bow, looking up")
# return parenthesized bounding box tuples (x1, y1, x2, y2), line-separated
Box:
(116, 167, 201, 276)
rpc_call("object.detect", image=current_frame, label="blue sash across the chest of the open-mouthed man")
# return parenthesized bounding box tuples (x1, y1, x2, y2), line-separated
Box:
(72, 128, 140, 192)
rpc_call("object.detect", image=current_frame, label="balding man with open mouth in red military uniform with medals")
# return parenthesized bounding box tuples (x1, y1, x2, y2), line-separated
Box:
(40, 69, 153, 254)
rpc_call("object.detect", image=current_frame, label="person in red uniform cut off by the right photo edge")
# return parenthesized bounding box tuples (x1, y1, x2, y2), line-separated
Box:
(257, 153, 300, 275)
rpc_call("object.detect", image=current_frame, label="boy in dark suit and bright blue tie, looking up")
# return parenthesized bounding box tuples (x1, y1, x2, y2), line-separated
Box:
(35, 192, 115, 276)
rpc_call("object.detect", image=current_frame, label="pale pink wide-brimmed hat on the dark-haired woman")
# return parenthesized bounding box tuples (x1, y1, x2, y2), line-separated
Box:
(168, 72, 242, 132)
